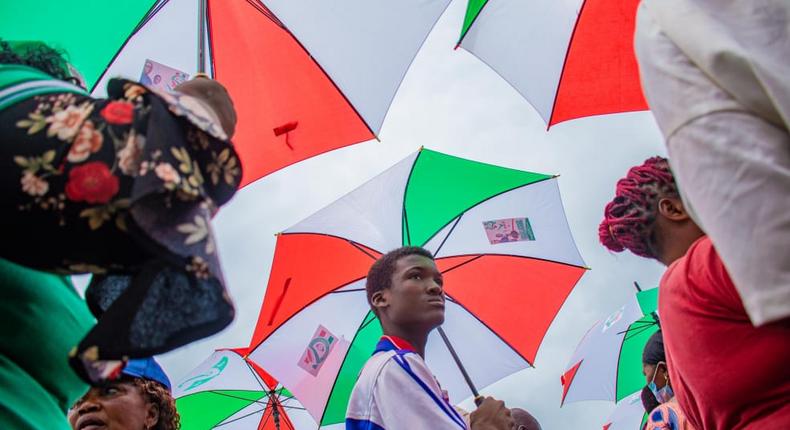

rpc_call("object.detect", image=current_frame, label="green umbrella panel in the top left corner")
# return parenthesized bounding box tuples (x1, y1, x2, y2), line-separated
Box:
(0, 0, 159, 88)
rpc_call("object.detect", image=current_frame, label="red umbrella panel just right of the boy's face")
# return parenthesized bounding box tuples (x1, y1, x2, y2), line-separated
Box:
(437, 255, 584, 363)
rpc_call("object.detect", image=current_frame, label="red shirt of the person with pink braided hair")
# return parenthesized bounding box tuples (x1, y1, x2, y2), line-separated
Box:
(658, 236, 790, 430)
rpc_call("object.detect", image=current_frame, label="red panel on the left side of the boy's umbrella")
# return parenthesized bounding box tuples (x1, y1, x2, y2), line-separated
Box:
(250, 234, 380, 348)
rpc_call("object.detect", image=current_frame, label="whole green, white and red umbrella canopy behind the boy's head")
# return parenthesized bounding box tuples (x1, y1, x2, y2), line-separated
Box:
(250, 149, 585, 425)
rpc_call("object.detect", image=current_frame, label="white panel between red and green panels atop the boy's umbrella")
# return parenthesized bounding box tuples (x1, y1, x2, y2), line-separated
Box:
(285, 152, 418, 253)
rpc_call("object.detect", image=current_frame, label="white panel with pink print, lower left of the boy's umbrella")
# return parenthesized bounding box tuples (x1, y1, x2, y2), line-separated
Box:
(250, 291, 369, 422)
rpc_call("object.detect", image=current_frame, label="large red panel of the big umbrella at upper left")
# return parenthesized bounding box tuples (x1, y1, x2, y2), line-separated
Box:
(208, 0, 374, 186)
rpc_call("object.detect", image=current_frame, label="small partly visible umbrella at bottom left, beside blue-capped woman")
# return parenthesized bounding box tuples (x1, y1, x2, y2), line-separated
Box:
(173, 349, 305, 430)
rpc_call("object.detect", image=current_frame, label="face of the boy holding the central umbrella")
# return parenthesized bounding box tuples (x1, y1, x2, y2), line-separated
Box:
(374, 255, 444, 332)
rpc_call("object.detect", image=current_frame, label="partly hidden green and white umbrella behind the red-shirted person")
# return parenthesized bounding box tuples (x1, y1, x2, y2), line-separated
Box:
(562, 288, 659, 404)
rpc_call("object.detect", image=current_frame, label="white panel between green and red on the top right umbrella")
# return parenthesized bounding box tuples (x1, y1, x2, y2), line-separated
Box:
(461, 0, 583, 123)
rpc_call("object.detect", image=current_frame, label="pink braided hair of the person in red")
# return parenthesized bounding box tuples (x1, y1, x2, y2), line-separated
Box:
(598, 157, 679, 258)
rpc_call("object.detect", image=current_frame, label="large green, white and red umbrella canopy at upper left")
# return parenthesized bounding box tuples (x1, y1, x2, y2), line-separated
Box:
(0, 0, 450, 186)
